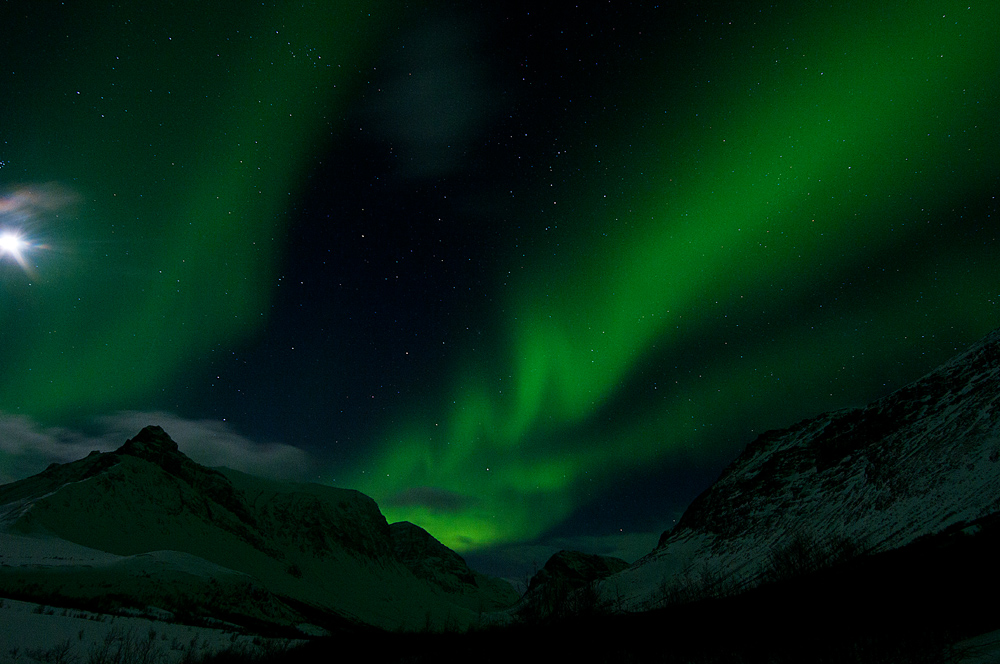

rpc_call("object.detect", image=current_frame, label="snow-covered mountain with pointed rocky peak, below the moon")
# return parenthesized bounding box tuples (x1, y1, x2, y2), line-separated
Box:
(0, 426, 517, 631)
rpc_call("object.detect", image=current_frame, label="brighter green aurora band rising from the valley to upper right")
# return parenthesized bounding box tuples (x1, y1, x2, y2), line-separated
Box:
(360, 3, 1000, 551)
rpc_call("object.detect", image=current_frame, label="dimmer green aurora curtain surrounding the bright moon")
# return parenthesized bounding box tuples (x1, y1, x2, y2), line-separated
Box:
(0, 2, 380, 420)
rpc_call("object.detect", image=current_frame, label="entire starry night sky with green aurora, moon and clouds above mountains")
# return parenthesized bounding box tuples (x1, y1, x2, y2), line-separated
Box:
(0, 0, 1000, 571)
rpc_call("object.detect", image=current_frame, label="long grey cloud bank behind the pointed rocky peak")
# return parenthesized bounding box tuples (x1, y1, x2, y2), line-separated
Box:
(0, 411, 314, 484)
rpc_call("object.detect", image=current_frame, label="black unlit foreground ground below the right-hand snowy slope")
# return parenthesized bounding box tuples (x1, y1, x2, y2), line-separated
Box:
(197, 517, 1000, 663)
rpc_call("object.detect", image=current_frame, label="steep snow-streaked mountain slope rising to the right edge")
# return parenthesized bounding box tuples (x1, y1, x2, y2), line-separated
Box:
(601, 330, 1000, 610)
